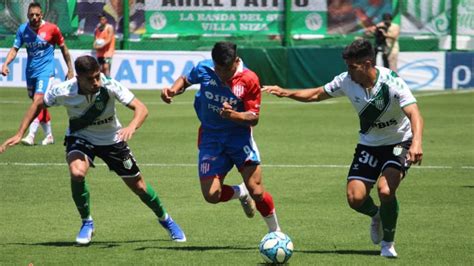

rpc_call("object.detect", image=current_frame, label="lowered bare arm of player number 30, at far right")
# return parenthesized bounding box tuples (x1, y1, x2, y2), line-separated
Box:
(403, 103, 423, 164)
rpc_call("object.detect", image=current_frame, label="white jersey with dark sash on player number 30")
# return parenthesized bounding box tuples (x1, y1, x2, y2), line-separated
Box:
(324, 67, 416, 146)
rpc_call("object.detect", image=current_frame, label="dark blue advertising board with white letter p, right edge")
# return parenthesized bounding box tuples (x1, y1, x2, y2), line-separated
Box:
(446, 53, 474, 89)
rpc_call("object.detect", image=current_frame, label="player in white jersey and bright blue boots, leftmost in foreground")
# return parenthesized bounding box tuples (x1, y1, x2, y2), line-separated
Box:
(0, 55, 186, 245)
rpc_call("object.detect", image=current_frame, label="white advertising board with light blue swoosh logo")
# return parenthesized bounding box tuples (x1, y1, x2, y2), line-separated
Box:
(398, 52, 446, 90)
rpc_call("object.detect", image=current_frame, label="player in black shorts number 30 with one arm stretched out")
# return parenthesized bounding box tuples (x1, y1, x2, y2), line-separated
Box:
(263, 40, 423, 257)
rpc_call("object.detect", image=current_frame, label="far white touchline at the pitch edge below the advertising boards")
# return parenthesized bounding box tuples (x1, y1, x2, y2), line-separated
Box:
(0, 90, 474, 105)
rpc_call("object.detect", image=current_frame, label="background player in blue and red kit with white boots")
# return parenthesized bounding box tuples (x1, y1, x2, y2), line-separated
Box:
(2, 3, 74, 145)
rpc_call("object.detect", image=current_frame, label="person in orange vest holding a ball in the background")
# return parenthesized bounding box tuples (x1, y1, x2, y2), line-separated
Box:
(94, 14, 115, 78)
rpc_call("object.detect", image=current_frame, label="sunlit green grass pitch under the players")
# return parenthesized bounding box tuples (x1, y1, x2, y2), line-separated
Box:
(0, 88, 474, 265)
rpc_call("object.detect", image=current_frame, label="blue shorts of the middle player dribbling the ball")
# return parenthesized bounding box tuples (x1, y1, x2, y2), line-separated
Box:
(198, 128, 260, 179)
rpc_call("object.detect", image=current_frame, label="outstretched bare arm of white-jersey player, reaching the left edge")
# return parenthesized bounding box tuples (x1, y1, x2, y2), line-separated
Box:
(0, 94, 46, 153)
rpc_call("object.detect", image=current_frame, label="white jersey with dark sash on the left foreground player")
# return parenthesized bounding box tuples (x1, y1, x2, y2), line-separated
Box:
(44, 74, 135, 145)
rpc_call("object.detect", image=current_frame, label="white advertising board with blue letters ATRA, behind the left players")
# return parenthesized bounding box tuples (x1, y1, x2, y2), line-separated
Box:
(0, 49, 211, 89)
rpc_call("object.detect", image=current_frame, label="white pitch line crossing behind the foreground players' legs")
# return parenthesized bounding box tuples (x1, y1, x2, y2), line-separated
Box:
(0, 162, 474, 170)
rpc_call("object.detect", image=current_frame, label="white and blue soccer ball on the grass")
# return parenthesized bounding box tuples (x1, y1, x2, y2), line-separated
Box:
(258, 232, 293, 263)
